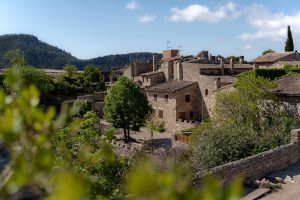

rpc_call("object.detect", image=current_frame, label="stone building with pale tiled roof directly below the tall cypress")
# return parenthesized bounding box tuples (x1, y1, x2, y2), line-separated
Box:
(251, 50, 300, 68)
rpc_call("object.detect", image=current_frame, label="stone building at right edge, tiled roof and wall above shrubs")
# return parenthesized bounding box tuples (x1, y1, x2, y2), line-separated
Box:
(274, 75, 300, 115)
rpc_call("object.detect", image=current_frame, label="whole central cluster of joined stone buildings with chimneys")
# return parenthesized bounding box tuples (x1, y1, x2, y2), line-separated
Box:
(119, 50, 253, 131)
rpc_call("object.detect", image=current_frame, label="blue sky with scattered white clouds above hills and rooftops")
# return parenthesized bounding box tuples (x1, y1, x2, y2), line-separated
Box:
(0, 0, 300, 59)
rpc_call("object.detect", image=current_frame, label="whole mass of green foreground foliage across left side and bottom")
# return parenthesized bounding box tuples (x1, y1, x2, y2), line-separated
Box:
(0, 49, 241, 200)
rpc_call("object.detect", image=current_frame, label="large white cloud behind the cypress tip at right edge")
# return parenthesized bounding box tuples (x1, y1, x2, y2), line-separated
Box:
(239, 5, 300, 41)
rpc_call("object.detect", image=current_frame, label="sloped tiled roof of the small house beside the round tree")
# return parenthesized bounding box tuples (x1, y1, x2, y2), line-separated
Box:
(145, 81, 197, 92)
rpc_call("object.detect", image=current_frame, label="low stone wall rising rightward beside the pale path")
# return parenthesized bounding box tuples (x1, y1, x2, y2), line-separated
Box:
(194, 129, 300, 186)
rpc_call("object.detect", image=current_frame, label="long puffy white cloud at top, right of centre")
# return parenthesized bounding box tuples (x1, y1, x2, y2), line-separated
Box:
(169, 2, 240, 23)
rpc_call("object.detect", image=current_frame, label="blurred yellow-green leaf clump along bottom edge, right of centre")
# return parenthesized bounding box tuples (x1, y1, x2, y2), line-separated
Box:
(127, 160, 243, 200)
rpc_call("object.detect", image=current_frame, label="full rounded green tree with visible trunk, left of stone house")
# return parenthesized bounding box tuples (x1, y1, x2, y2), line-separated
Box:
(104, 77, 151, 142)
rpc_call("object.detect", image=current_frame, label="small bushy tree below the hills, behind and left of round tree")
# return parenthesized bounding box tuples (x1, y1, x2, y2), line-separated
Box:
(81, 64, 105, 92)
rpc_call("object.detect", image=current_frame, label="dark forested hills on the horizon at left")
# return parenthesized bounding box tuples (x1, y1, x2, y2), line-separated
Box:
(0, 34, 159, 71)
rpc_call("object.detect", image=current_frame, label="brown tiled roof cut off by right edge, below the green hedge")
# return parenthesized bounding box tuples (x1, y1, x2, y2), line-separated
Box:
(274, 75, 300, 96)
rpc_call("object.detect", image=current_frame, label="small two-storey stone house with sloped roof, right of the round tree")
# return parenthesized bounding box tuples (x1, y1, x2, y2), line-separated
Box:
(145, 81, 201, 130)
